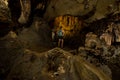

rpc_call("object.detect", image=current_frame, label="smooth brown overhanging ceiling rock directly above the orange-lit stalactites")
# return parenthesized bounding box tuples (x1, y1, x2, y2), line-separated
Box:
(44, 0, 96, 21)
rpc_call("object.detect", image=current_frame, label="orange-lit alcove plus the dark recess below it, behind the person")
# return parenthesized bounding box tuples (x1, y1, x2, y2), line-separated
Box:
(50, 15, 83, 49)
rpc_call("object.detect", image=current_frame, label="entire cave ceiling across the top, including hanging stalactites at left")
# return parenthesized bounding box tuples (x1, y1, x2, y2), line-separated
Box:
(0, 0, 117, 32)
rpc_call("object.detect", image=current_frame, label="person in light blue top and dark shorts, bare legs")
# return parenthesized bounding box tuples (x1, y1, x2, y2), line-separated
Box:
(57, 26, 64, 48)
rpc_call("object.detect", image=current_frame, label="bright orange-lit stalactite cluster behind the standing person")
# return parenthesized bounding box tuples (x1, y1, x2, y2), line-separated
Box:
(54, 15, 82, 36)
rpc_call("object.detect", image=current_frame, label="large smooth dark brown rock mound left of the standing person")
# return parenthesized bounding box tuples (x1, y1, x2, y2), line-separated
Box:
(18, 17, 52, 51)
